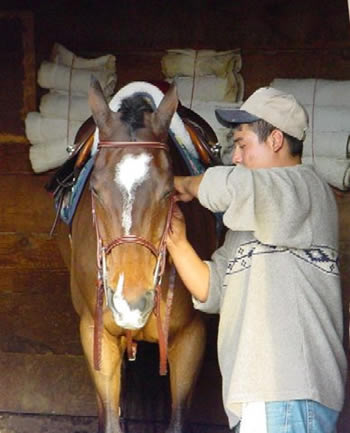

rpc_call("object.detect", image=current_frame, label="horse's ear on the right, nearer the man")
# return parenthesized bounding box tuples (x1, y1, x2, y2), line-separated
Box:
(153, 82, 179, 140)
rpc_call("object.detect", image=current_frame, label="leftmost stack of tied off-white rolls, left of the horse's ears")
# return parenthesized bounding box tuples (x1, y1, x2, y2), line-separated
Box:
(25, 43, 117, 173)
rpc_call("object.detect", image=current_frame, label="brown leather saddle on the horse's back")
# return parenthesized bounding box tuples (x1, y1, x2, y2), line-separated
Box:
(45, 104, 221, 230)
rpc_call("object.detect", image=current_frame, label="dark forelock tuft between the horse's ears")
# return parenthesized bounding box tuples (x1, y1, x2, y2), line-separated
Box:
(118, 94, 154, 130)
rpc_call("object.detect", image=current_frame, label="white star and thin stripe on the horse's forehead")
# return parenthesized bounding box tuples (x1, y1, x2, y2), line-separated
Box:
(114, 153, 152, 235)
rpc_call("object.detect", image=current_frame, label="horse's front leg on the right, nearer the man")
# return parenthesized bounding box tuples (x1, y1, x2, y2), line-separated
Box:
(167, 314, 206, 433)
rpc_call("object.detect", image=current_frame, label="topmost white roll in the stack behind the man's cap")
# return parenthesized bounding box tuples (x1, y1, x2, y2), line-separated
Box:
(271, 78, 350, 106)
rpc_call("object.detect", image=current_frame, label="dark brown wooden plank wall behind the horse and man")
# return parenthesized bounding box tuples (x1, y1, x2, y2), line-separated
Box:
(0, 0, 350, 433)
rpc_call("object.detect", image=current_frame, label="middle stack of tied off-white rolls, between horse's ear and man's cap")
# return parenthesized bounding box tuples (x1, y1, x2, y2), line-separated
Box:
(161, 49, 244, 162)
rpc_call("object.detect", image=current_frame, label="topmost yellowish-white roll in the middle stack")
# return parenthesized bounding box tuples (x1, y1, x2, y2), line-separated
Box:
(161, 49, 242, 78)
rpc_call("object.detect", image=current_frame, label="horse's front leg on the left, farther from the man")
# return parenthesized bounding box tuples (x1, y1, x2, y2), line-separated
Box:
(80, 313, 124, 433)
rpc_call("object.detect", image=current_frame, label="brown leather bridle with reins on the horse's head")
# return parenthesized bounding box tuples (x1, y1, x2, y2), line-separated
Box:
(91, 140, 175, 375)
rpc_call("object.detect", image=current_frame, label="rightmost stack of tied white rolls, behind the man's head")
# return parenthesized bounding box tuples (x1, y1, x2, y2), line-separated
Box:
(271, 78, 350, 191)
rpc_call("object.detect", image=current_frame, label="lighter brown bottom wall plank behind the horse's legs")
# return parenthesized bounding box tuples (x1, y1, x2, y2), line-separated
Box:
(0, 352, 227, 424)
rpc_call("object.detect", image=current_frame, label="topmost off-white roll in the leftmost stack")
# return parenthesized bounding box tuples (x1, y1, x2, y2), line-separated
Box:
(51, 43, 116, 72)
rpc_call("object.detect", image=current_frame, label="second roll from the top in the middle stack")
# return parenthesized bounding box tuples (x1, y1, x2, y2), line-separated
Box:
(174, 73, 240, 102)
